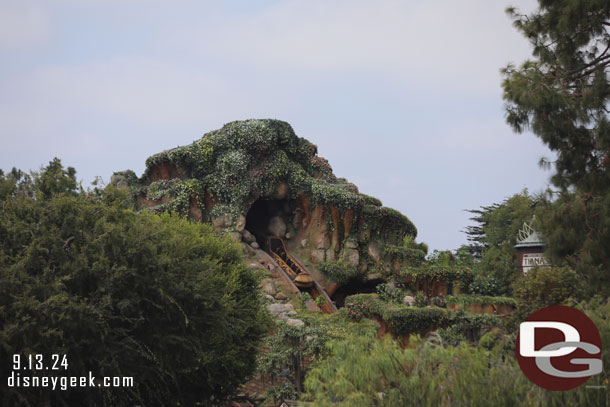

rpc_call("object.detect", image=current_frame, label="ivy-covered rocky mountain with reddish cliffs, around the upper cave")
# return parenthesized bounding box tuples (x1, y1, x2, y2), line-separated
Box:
(113, 120, 417, 286)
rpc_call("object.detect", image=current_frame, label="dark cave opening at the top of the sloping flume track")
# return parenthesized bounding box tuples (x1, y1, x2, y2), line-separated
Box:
(246, 198, 291, 250)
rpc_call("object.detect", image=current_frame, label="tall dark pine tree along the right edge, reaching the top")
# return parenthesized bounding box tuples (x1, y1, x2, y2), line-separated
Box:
(503, 0, 610, 293)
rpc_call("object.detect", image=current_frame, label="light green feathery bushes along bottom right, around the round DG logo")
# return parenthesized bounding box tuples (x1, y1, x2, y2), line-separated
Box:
(304, 301, 610, 407)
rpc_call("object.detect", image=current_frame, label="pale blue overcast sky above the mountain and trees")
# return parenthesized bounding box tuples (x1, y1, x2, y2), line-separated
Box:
(0, 0, 551, 253)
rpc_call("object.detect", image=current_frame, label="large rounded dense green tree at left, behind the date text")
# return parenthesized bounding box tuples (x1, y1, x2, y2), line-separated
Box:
(0, 160, 266, 407)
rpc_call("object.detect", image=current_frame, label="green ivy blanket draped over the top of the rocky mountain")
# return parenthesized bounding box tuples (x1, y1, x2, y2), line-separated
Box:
(137, 120, 416, 250)
